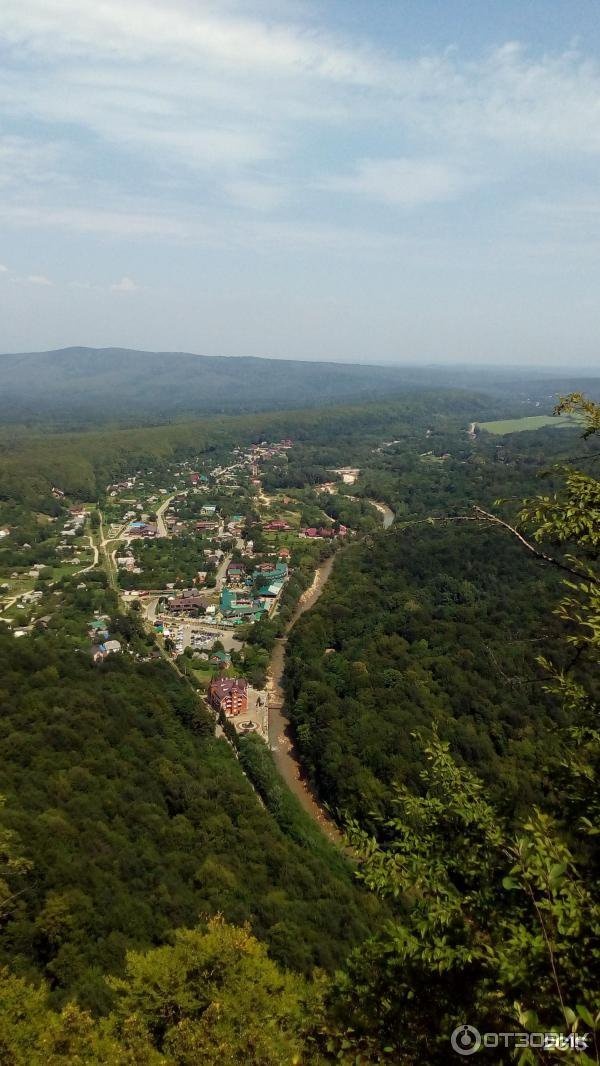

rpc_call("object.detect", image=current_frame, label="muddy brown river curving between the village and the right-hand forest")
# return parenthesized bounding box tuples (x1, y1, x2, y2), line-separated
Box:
(266, 500, 394, 845)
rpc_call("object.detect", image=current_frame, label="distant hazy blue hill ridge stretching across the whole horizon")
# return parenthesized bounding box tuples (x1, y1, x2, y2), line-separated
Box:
(0, 348, 599, 425)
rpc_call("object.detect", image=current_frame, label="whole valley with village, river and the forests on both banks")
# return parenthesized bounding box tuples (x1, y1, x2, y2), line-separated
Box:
(0, 395, 588, 1061)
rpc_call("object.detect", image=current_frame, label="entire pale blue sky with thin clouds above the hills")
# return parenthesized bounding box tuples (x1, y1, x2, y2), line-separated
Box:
(0, 0, 600, 369)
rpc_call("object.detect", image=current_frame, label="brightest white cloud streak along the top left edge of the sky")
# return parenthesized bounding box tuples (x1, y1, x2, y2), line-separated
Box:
(2, 0, 393, 84)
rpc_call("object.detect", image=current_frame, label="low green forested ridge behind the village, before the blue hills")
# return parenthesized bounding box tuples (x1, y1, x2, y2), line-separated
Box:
(0, 389, 526, 506)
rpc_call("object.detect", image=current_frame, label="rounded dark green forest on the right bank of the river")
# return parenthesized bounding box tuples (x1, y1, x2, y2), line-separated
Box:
(287, 523, 562, 825)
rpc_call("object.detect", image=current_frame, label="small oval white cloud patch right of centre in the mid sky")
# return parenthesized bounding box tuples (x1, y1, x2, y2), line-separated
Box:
(320, 159, 472, 208)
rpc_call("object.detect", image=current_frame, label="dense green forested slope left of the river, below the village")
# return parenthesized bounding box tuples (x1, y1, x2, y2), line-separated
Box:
(0, 587, 371, 1008)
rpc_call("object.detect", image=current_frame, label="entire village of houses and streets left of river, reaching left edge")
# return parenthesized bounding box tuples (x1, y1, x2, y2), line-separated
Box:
(0, 428, 394, 740)
